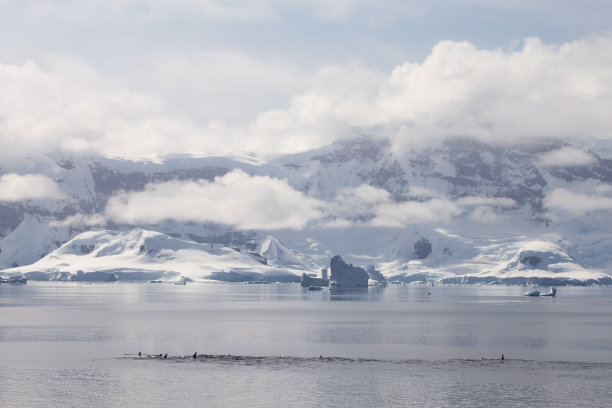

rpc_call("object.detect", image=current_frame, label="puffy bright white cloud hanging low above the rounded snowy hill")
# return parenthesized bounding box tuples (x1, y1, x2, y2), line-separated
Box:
(106, 170, 322, 229)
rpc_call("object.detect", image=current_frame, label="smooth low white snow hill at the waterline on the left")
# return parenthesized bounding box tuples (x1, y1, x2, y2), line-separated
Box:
(4, 228, 301, 281)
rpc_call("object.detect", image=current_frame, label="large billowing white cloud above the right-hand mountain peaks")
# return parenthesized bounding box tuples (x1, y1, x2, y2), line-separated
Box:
(247, 37, 612, 151)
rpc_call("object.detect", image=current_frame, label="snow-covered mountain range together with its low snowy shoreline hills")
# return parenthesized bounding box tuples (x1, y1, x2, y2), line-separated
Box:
(0, 137, 612, 283)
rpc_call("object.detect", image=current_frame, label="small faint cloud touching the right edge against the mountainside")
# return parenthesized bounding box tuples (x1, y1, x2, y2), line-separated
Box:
(544, 188, 612, 216)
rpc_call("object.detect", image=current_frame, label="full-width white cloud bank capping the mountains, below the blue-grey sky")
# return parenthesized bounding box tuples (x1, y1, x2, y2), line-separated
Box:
(0, 36, 612, 160)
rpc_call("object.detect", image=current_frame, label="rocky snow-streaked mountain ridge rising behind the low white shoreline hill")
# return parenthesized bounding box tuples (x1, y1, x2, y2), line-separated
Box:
(0, 137, 612, 281)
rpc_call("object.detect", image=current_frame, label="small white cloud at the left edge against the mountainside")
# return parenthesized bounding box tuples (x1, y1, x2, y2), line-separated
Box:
(0, 173, 65, 202)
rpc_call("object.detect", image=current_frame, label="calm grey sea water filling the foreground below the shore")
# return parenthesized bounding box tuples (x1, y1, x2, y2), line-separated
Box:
(0, 282, 612, 407)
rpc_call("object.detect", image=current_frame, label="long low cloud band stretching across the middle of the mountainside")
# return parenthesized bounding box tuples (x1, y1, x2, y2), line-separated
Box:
(52, 176, 517, 230)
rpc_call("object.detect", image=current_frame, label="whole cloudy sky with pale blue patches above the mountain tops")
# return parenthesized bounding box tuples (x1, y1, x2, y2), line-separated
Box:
(0, 0, 612, 157)
